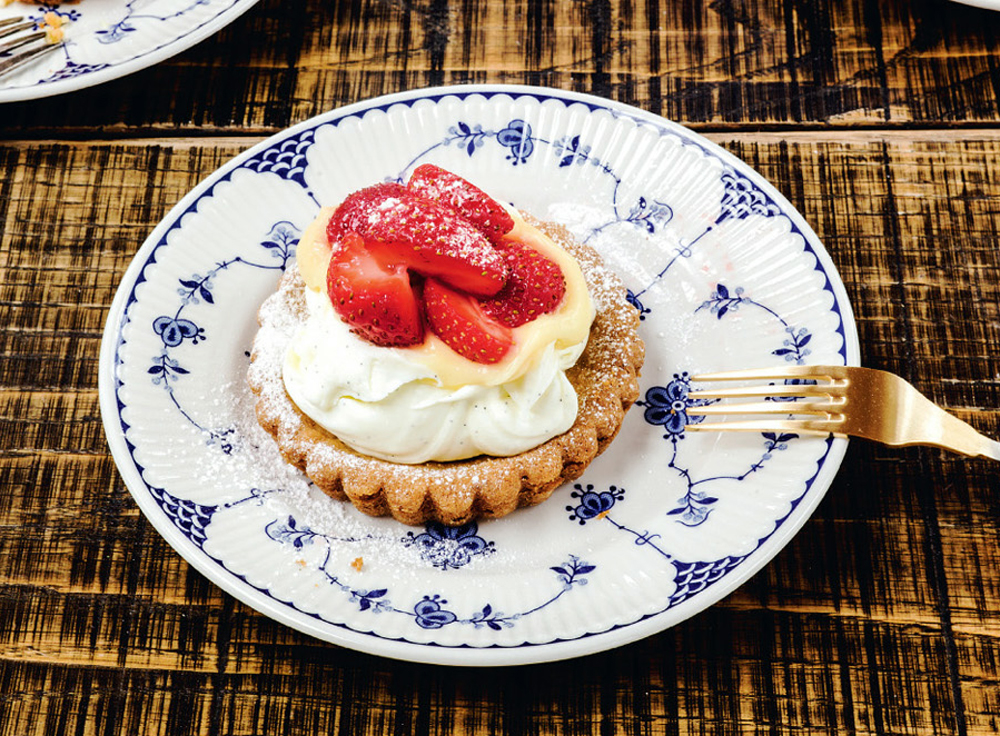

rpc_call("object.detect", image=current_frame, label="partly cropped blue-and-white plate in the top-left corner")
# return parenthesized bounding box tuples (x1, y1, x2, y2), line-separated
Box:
(0, 0, 257, 102)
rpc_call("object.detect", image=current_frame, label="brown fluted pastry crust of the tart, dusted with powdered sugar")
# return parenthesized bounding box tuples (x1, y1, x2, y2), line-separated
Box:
(248, 218, 645, 526)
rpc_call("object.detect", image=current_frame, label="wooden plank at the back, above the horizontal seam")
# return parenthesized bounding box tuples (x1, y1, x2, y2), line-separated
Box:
(0, 0, 1000, 134)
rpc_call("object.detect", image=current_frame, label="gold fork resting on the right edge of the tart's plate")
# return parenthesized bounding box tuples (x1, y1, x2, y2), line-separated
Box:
(686, 365, 1000, 460)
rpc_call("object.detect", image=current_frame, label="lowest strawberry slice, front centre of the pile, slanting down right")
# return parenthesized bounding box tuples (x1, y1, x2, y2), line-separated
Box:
(424, 279, 514, 363)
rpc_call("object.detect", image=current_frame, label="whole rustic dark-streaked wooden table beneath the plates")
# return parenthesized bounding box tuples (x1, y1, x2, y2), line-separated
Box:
(0, 0, 1000, 736)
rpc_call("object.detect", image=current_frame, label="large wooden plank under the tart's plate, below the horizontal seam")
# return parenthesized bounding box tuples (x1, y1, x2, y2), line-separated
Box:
(0, 130, 1000, 736)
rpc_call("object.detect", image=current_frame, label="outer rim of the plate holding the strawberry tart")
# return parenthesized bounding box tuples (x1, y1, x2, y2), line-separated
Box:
(98, 82, 860, 666)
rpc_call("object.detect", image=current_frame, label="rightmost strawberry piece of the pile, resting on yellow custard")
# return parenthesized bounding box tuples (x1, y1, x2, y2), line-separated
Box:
(481, 240, 566, 327)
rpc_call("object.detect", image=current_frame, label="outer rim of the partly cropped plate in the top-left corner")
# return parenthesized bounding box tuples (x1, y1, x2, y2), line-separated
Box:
(0, 0, 260, 104)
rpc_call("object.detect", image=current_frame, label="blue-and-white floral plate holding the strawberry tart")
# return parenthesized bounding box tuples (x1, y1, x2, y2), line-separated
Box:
(100, 86, 858, 665)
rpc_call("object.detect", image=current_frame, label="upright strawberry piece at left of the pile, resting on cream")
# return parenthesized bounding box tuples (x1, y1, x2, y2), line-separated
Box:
(326, 233, 424, 347)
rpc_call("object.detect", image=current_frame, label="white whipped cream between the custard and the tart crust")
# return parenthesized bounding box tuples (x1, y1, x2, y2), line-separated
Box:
(284, 288, 593, 464)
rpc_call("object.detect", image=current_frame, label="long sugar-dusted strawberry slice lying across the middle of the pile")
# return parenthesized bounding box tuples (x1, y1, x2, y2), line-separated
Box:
(327, 184, 507, 296)
